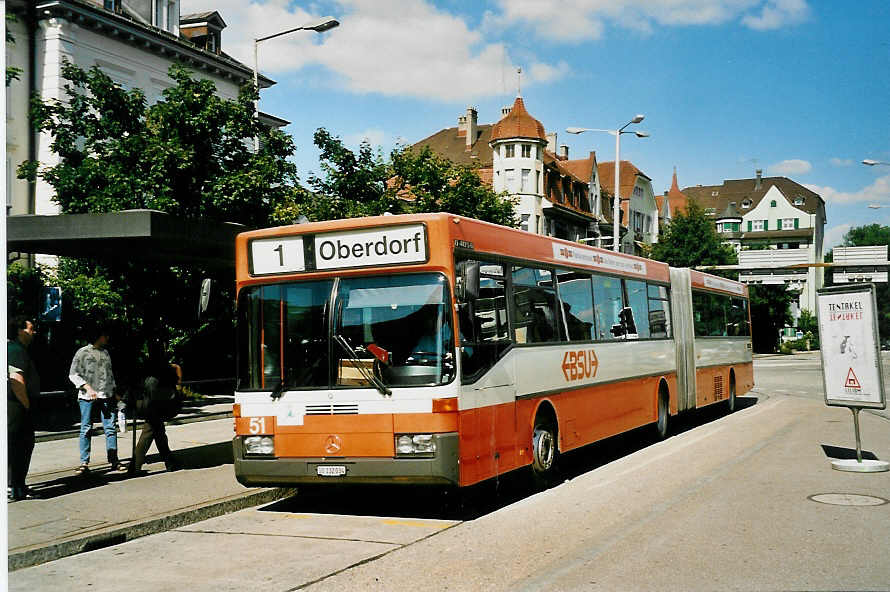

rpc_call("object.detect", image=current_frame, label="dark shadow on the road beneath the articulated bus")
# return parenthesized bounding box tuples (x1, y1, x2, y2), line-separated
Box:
(260, 396, 757, 520)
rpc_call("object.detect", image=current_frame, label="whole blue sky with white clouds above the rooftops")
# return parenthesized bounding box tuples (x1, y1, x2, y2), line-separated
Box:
(181, 0, 890, 248)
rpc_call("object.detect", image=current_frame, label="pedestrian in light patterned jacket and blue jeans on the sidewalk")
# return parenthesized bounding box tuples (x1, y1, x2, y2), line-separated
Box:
(68, 325, 122, 475)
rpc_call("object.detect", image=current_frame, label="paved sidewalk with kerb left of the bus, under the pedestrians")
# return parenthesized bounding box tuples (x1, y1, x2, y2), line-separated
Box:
(8, 414, 293, 570)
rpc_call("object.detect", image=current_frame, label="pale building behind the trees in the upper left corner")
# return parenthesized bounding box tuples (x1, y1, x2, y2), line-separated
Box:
(6, 0, 278, 220)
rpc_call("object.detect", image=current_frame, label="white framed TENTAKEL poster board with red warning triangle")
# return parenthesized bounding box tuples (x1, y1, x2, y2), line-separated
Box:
(817, 284, 886, 409)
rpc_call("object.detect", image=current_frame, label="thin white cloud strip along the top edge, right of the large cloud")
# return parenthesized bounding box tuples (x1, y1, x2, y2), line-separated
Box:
(485, 0, 809, 42)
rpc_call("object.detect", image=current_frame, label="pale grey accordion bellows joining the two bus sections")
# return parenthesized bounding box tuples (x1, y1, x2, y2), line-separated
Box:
(671, 267, 695, 411)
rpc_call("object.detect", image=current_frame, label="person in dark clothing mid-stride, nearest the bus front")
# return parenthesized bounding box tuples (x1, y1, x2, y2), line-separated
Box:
(128, 356, 182, 475)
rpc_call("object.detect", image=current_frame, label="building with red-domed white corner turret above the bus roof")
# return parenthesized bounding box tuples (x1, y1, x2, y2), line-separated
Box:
(412, 97, 611, 240)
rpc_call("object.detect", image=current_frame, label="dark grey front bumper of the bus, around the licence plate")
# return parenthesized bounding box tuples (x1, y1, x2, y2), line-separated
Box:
(232, 433, 459, 487)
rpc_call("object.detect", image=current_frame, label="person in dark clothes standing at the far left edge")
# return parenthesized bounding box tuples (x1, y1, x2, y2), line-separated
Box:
(6, 316, 40, 501)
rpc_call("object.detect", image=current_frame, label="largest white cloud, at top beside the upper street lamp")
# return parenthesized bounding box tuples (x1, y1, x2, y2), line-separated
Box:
(182, 0, 568, 101)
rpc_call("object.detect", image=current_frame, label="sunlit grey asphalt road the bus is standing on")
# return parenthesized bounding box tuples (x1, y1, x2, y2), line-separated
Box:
(9, 355, 890, 591)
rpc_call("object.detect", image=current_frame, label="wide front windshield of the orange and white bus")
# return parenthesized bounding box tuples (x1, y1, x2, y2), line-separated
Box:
(238, 273, 455, 390)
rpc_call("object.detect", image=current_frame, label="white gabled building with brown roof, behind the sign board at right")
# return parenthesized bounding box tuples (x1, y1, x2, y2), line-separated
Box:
(682, 170, 826, 316)
